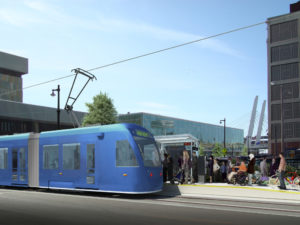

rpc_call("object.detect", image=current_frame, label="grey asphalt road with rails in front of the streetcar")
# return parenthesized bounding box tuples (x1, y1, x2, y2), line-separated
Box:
(0, 188, 300, 225)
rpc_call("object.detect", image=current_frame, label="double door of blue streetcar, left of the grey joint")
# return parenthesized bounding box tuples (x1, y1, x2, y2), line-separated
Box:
(12, 148, 28, 185)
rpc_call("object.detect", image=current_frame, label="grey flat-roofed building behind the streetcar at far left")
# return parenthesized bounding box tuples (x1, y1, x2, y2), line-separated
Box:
(0, 52, 85, 135)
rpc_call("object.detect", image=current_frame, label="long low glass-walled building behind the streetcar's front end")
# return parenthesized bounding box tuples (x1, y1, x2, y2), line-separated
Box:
(118, 113, 244, 146)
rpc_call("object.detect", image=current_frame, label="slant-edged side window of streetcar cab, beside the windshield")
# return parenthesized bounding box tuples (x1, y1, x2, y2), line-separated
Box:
(116, 140, 138, 166)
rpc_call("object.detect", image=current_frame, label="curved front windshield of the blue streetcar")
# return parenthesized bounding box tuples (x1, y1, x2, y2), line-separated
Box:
(134, 136, 161, 167)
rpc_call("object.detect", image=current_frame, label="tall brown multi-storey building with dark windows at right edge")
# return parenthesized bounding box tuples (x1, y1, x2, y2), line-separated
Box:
(267, 1, 300, 155)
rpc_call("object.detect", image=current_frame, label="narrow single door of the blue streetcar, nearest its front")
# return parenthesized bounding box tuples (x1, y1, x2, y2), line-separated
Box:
(85, 144, 96, 188)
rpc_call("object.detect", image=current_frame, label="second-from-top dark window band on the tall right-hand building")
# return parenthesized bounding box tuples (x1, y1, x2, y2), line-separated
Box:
(271, 43, 298, 62)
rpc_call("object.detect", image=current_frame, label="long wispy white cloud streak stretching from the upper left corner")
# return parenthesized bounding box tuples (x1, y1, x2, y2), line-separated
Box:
(0, 0, 243, 58)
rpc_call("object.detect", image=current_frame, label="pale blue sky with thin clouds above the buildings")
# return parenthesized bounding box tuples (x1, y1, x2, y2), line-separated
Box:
(0, 0, 296, 136)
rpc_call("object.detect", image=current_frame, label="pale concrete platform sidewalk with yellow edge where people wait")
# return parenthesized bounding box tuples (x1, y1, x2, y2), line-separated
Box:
(158, 183, 300, 205)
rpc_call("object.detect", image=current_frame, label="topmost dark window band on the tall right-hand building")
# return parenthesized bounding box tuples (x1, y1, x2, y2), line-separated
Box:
(270, 20, 298, 43)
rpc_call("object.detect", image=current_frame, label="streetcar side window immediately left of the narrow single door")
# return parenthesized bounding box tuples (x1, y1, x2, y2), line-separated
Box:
(63, 143, 80, 170)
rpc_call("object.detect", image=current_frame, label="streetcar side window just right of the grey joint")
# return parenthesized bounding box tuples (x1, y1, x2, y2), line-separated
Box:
(43, 145, 58, 169)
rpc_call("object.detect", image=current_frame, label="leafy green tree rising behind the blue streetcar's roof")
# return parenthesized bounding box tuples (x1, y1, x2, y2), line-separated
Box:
(82, 92, 117, 126)
